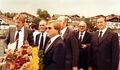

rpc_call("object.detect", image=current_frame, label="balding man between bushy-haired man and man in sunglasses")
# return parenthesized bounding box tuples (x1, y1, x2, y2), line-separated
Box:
(35, 20, 50, 51)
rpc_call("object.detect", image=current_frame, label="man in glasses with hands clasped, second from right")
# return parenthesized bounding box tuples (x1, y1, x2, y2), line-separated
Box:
(75, 21, 91, 70)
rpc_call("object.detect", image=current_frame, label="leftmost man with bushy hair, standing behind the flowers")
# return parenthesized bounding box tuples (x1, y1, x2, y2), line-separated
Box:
(5, 14, 34, 49)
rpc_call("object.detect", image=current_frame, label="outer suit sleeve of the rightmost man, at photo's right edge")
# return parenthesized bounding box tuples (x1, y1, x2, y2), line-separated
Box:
(111, 33, 119, 70)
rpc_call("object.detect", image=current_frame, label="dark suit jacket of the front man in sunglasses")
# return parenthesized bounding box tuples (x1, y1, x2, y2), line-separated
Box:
(44, 37, 66, 70)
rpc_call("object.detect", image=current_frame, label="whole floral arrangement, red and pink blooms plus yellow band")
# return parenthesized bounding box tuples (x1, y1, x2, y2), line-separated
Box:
(5, 42, 44, 70)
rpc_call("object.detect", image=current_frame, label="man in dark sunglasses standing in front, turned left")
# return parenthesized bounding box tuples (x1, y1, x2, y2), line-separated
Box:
(44, 20, 66, 70)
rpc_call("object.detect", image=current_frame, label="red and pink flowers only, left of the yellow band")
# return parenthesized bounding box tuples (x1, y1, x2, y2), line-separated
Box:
(5, 43, 32, 70)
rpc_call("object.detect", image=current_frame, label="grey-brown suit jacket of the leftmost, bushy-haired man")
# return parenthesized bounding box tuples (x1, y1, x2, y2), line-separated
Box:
(5, 27, 34, 45)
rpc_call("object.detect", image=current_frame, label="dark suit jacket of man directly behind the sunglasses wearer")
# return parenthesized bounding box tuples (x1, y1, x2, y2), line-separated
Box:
(63, 28, 79, 70)
